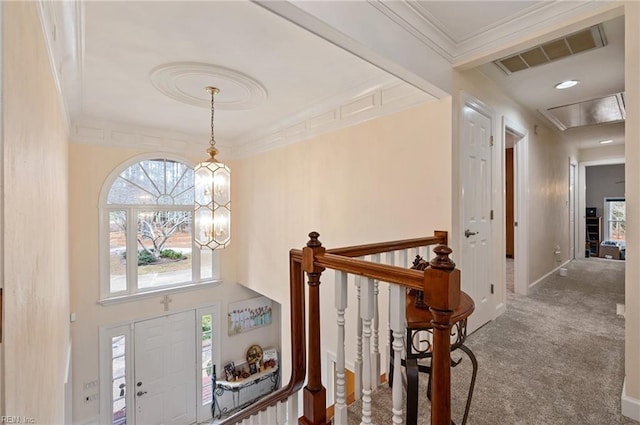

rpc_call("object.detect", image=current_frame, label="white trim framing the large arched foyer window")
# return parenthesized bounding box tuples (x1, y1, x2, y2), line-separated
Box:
(98, 152, 222, 305)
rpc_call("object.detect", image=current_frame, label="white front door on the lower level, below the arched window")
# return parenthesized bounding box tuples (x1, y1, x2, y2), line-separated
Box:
(133, 310, 196, 425)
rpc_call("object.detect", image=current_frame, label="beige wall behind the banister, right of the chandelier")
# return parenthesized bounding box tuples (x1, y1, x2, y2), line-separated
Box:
(234, 99, 455, 382)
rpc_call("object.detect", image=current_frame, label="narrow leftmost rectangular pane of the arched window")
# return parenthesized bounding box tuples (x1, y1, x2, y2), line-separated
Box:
(109, 211, 127, 292)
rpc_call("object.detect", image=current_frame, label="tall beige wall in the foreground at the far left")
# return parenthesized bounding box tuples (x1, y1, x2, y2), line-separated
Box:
(0, 2, 69, 424)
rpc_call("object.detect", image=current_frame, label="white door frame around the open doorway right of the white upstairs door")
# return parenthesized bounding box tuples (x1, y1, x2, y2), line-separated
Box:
(502, 116, 529, 295)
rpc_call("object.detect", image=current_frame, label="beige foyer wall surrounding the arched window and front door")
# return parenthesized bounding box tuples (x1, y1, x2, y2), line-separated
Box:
(69, 143, 279, 423)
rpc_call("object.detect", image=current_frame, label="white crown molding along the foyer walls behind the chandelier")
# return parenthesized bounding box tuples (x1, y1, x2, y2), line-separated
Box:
(70, 82, 436, 159)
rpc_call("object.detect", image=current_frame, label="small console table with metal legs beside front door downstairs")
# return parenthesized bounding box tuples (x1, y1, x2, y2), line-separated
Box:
(211, 366, 280, 419)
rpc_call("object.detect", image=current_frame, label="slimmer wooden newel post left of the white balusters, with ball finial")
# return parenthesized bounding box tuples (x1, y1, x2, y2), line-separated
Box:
(298, 232, 327, 425)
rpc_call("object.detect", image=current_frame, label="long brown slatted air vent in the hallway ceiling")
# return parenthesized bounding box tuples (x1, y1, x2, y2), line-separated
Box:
(494, 24, 607, 74)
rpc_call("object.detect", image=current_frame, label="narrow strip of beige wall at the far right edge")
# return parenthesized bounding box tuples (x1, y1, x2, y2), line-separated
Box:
(623, 2, 640, 404)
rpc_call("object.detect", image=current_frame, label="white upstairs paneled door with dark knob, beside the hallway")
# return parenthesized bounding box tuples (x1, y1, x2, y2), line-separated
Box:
(461, 102, 493, 332)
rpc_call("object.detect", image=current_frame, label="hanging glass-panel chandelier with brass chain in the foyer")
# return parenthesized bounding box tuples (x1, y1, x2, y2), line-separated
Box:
(194, 87, 231, 250)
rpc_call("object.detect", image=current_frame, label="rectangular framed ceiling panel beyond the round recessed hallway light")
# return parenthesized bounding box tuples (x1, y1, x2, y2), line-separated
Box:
(540, 93, 625, 131)
